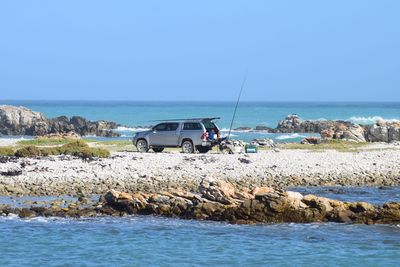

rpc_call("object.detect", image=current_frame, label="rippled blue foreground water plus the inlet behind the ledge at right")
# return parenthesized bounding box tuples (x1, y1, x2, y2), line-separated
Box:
(0, 187, 400, 266)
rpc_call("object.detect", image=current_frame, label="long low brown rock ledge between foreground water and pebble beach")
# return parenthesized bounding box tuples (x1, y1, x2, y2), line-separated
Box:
(0, 180, 400, 224)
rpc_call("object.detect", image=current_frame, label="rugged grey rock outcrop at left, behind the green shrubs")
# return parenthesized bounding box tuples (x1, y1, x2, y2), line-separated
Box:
(0, 106, 118, 137)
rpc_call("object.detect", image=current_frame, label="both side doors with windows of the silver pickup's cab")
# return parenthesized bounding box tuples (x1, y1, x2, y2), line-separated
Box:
(149, 122, 179, 146)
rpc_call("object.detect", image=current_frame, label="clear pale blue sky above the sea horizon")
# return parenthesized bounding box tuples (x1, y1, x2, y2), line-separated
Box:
(0, 0, 400, 101)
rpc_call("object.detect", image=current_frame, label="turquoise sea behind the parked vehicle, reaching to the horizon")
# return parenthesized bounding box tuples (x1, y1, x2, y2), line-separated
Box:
(0, 100, 400, 142)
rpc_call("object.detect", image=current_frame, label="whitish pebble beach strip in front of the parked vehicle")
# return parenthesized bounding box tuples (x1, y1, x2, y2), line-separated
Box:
(0, 144, 400, 195)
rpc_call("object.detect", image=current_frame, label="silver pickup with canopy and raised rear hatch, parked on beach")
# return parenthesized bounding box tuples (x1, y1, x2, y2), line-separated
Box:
(132, 118, 221, 153)
